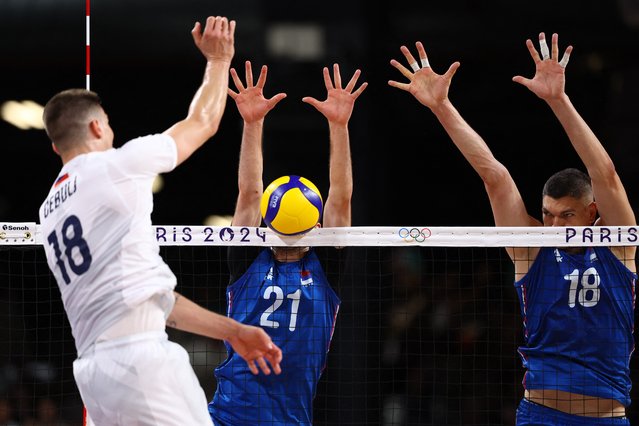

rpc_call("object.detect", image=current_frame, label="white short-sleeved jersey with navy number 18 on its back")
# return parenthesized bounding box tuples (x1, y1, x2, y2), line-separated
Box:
(40, 134, 177, 355)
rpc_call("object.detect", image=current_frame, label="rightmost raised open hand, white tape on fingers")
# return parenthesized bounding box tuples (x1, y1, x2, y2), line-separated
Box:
(513, 33, 572, 101)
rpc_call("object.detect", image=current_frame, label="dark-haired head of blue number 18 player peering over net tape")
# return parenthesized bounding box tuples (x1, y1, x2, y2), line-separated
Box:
(541, 168, 597, 226)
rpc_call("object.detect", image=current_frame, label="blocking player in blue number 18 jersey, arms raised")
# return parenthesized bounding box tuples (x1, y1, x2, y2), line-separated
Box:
(389, 33, 637, 426)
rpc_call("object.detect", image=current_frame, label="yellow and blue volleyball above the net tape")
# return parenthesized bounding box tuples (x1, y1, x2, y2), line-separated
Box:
(260, 175, 323, 235)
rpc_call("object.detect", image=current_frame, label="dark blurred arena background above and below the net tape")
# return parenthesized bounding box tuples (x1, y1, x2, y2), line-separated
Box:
(0, 0, 639, 425)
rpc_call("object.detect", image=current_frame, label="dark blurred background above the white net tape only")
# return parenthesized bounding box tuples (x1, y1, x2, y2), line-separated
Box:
(0, 0, 639, 226)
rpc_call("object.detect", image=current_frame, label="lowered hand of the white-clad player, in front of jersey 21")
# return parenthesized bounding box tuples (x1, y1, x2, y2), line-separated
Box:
(228, 325, 282, 374)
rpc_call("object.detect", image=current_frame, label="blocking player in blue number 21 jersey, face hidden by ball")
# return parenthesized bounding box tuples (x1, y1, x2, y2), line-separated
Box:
(209, 61, 366, 426)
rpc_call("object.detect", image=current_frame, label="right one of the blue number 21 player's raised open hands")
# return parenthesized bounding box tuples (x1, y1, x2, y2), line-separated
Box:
(302, 64, 368, 125)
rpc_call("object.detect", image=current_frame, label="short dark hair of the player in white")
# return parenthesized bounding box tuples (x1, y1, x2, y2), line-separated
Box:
(42, 89, 102, 149)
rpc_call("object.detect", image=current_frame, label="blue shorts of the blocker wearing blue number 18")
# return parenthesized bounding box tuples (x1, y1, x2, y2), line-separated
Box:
(517, 398, 630, 426)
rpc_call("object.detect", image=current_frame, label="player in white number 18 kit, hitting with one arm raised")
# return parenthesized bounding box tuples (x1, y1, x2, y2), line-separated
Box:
(39, 17, 282, 426)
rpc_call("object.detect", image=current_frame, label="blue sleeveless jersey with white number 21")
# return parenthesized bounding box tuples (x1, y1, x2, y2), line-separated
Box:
(209, 249, 340, 426)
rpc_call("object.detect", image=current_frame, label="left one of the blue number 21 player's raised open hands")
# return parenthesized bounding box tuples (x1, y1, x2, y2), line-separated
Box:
(228, 61, 286, 123)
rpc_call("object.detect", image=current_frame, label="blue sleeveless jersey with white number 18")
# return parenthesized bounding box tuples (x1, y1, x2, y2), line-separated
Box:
(515, 247, 636, 406)
